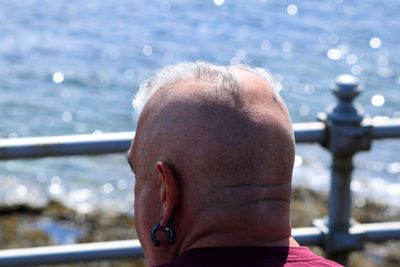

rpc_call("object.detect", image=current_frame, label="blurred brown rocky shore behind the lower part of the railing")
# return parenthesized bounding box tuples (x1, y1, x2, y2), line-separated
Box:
(0, 188, 400, 267)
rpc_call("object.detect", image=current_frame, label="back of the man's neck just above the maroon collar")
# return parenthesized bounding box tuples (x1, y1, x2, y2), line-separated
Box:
(178, 200, 299, 254)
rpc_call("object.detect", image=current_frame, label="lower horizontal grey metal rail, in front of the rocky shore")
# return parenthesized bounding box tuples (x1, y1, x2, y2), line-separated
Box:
(0, 222, 400, 267)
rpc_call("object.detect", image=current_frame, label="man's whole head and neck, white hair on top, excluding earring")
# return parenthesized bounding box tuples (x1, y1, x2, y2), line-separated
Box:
(129, 62, 294, 265)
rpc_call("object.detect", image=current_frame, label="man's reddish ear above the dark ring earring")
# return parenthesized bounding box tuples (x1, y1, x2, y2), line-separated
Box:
(156, 161, 180, 226)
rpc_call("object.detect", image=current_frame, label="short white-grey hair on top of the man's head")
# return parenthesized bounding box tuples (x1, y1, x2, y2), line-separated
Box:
(132, 61, 279, 117)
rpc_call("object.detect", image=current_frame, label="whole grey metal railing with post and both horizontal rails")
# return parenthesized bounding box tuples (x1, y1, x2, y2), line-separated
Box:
(0, 75, 400, 266)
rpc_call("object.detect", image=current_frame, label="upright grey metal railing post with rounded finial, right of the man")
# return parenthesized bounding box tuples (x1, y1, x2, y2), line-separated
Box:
(315, 75, 371, 265)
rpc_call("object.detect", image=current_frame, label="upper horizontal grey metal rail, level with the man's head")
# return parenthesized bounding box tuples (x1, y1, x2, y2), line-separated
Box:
(0, 119, 400, 160)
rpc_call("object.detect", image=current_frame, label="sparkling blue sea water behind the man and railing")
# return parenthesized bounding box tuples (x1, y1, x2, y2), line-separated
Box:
(0, 0, 400, 212)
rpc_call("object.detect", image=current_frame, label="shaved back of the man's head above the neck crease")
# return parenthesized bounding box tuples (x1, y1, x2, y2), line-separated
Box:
(135, 64, 293, 193)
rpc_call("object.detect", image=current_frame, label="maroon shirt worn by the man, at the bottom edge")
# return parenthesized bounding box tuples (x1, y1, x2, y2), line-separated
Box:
(155, 247, 342, 267)
